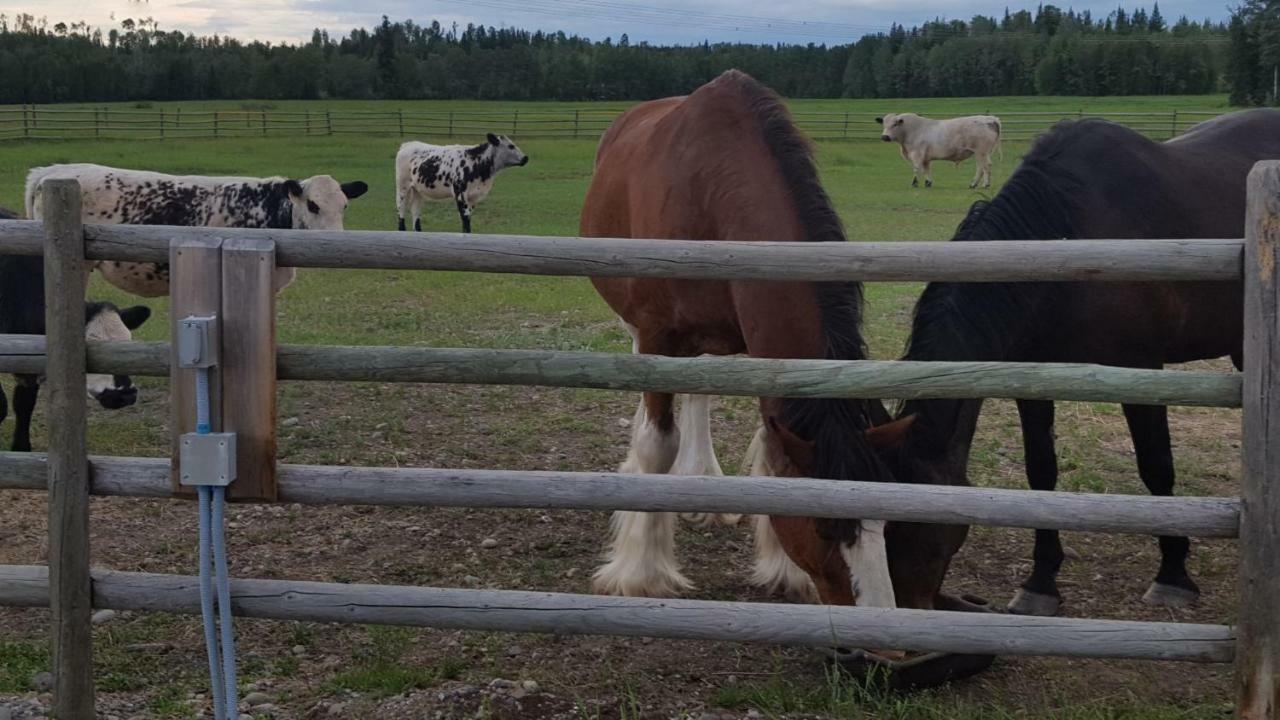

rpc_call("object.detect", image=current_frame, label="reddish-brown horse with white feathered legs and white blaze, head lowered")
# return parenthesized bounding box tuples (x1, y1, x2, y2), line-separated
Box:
(581, 70, 916, 606)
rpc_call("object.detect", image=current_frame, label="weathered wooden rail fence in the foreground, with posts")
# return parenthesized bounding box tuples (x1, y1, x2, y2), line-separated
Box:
(0, 161, 1280, 720)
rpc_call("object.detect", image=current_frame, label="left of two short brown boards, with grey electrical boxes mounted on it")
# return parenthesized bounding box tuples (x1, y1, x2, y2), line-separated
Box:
(168, 236, 223, 498)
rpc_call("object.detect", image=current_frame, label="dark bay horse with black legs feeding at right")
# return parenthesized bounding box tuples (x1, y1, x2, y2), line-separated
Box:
(887, 110, 1280, 615)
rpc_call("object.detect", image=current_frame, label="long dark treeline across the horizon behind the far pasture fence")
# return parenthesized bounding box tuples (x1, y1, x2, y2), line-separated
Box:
(0, 5, 1226, 104)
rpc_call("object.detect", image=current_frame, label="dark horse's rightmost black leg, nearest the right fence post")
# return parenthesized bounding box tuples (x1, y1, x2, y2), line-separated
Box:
(1124, 405, 1199, 607)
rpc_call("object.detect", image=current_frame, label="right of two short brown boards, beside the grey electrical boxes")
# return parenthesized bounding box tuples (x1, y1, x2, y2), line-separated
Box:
(219, 238, 276, 502)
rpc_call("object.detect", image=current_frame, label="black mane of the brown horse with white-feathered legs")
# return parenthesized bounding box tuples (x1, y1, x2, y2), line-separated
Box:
(718, 70, 888, 542)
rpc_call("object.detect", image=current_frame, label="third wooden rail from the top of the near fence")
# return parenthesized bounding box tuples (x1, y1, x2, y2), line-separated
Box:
(0, 452, 1240, 535)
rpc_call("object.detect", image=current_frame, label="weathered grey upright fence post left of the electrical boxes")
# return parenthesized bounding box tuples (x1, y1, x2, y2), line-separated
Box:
(41, 179, 95, 720)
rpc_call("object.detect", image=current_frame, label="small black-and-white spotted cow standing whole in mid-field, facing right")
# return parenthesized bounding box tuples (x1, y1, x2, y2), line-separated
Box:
(396, 133, 529, 232)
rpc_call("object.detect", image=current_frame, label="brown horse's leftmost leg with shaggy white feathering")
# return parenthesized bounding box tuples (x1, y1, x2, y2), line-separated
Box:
(593, 392, 692, 597)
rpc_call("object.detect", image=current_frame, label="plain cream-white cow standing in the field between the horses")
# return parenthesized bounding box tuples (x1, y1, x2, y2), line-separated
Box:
(876, 113, 1000, 187)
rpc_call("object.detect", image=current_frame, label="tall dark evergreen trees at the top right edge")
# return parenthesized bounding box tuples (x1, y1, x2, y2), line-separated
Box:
(1226, 0, 1280, 105)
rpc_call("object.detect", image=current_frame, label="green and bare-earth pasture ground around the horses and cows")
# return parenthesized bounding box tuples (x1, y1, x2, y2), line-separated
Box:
(0, 96, 1239, 720)
